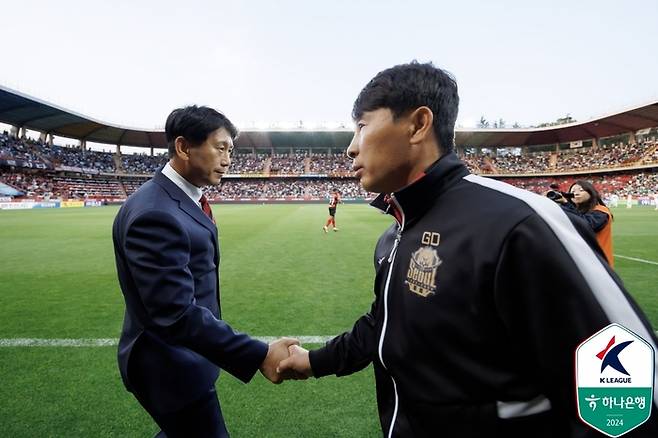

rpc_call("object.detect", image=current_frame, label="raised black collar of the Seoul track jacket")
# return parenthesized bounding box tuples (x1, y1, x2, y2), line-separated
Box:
(370, 152, 470, 227)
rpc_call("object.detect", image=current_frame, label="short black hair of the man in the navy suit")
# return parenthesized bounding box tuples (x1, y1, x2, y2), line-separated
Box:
(165, 105, 238, 158)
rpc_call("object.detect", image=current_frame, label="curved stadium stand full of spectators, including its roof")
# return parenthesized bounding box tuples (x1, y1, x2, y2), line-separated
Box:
(0, 87, 658, 207)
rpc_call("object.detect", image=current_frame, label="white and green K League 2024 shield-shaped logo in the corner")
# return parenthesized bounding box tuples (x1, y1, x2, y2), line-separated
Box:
(576, 324, 655, 437)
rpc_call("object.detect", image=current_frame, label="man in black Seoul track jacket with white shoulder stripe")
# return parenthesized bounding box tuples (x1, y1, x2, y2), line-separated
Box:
(279, 62, 658, 437)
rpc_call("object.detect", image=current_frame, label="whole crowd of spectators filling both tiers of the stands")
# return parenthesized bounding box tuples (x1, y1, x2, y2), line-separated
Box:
(0, 132, 658, 200)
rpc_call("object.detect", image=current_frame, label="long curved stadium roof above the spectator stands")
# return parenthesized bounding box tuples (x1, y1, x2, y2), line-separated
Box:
(0, 86, 658, 149)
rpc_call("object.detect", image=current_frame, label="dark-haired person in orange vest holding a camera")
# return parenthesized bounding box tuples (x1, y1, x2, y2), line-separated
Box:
(569, 180, 614, 268)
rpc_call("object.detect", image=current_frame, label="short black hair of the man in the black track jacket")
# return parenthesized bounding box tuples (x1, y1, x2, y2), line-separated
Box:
(352, 60, 459, 153)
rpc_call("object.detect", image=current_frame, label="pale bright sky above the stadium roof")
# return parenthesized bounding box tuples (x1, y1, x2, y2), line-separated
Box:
(0, 0, 658, 134)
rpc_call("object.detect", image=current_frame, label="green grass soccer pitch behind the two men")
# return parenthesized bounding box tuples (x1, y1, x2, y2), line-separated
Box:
(0, 204, 658, 438)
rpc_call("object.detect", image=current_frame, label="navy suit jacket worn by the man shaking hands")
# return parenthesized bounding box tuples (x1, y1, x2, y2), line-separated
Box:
(112, 170, 268, 413)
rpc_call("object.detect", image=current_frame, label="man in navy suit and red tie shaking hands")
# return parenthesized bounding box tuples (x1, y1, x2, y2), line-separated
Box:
(112, 106, 298, 438)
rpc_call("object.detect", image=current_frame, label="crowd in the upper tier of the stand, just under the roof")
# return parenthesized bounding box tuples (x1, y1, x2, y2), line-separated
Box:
(0, 133, 658, 176)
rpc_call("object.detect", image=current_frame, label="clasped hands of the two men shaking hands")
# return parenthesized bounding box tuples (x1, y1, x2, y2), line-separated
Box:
(260, 338, 313, 384)
